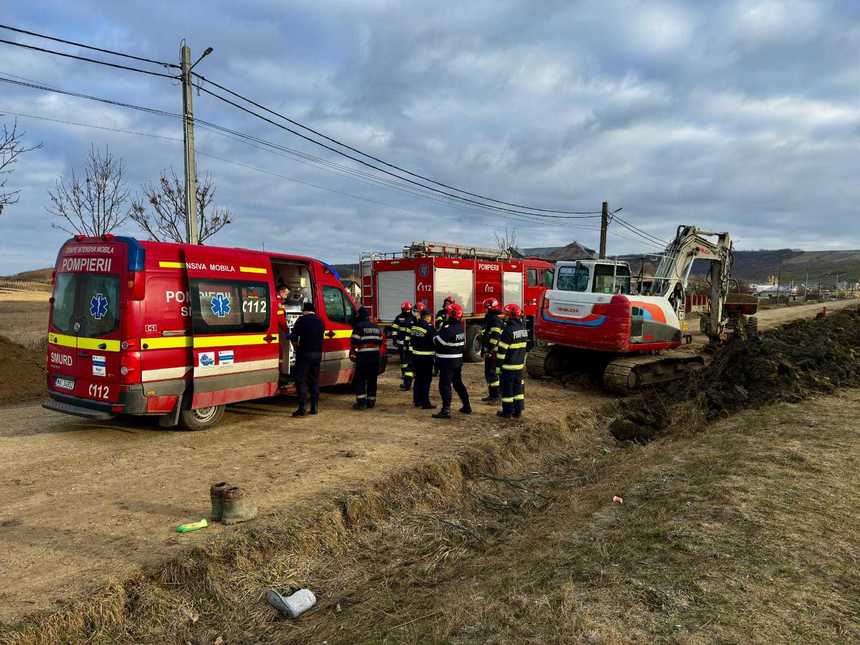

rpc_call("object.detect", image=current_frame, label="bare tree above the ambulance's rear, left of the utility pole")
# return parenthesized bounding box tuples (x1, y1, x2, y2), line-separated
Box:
(46, 146, 129, 237)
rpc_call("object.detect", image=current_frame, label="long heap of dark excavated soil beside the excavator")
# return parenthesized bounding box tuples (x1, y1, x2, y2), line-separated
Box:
(610, 309, 860, 441)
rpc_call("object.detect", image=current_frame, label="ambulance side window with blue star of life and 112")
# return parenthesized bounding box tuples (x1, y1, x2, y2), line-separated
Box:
(191, 280, 271, 334)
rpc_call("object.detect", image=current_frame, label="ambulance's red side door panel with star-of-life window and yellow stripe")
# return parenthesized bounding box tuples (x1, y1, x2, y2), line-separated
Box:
(184, 247, 280, 409)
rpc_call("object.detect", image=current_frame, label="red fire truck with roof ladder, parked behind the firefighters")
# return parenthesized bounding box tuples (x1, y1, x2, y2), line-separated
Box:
(359, 241, 553, 362)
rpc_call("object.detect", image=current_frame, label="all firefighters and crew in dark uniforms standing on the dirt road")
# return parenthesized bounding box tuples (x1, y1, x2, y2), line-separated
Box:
(279, 293, 529, 419)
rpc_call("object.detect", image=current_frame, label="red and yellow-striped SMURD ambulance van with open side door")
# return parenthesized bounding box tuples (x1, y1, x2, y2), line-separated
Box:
(43, 234, 385, 430)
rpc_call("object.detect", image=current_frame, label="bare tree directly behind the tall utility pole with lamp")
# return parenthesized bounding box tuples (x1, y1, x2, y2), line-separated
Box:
(131, 168, 230, 242)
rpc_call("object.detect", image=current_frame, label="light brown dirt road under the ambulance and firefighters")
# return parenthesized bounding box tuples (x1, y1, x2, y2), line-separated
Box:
(0, 365, 607, 623)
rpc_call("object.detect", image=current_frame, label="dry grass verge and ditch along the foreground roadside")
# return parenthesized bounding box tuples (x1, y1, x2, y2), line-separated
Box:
(0, 384, 860, 643)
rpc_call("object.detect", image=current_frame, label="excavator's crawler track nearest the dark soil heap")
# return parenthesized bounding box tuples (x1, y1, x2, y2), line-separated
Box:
(603, 352, 705, 395)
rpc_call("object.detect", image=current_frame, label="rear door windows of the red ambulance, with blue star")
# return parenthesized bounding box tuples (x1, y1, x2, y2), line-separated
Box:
(51, 273, 119, 337)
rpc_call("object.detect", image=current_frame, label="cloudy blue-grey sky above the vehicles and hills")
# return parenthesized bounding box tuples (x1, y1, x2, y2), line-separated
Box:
(0, 0, 860, 274)
